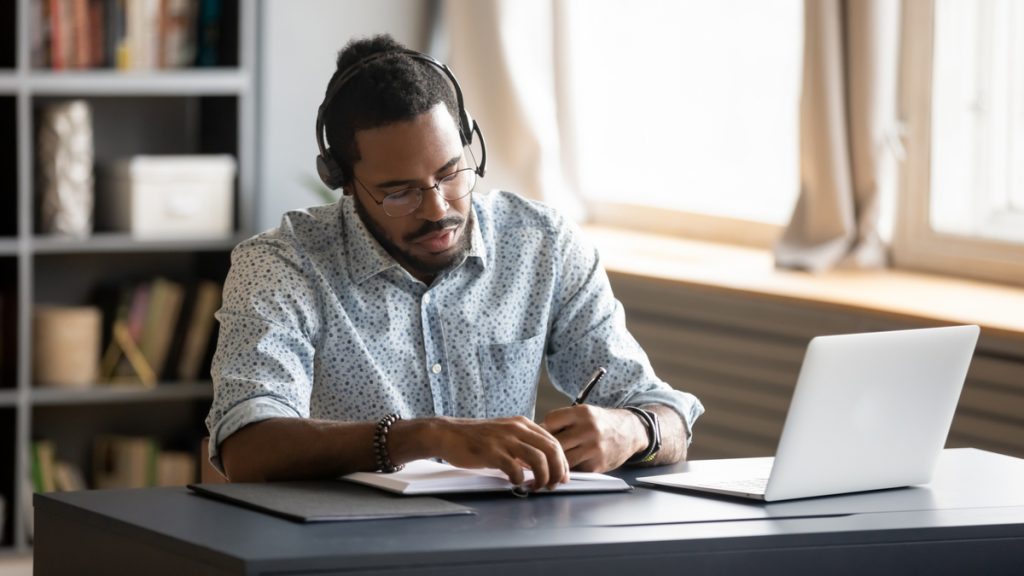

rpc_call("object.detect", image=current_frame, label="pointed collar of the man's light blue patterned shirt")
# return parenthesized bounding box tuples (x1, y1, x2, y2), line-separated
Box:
(338, 196, 487, 284)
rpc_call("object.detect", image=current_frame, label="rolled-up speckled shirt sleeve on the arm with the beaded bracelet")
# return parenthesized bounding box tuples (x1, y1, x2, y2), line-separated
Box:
(206, 231, 317, 471)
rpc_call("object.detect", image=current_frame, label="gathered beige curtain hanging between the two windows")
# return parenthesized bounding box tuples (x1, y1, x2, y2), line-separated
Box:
(775, 0, 900, 272)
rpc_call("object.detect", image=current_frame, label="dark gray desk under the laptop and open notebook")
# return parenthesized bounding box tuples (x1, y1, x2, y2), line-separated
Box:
(35, 449, 1024, 576)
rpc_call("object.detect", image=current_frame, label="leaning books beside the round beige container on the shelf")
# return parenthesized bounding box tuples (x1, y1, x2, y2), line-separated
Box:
(101, 278, 220, 385)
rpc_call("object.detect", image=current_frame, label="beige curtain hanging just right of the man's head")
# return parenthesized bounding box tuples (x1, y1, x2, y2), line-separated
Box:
(442, 0, 583, 219)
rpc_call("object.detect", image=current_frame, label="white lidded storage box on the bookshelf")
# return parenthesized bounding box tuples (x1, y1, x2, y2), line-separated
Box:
(101, 155, 237, 240)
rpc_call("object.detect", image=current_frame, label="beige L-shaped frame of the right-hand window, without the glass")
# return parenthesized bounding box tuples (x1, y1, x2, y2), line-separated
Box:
(892, 0, 1024, 285)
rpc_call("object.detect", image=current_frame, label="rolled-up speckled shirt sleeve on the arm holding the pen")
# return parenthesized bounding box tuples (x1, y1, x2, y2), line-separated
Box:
(547, 219, 703, 441)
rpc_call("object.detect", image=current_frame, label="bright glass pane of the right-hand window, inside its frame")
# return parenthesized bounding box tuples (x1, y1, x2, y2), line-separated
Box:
(930, 0, 1024, 243)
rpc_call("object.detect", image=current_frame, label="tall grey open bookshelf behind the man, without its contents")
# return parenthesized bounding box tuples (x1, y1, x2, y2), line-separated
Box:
(0, 0, 259, 556)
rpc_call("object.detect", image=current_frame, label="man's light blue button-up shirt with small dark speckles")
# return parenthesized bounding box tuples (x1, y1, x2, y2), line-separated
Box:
(207, 192, 703, 467)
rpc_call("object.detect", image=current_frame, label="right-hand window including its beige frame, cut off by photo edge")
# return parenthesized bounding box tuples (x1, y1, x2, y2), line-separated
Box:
(894, 0, 1024, 284)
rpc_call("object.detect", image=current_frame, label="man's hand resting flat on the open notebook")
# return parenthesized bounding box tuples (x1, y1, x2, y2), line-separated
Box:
(411, 416, 569, 490)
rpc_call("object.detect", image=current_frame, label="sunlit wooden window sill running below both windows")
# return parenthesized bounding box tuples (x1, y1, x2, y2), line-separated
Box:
(585, 225, 1024, 339)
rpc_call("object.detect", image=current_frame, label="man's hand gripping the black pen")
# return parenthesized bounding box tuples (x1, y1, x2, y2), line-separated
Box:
(542, 405, 647, 472)
